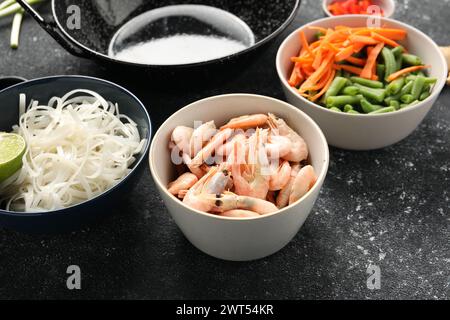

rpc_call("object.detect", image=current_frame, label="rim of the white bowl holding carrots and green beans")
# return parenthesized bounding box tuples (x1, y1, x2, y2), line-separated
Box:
(276, 15, 448, 119)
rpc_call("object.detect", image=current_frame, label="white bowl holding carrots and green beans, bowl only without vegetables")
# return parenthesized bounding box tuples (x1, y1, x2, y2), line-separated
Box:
(276, 15, 447, 150)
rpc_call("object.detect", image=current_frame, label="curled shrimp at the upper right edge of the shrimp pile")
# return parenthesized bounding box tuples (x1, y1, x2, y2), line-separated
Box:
(268, 113, 309, 162)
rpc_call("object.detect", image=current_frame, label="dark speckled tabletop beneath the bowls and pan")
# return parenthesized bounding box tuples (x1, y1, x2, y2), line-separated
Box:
(0, 0, 450, 299)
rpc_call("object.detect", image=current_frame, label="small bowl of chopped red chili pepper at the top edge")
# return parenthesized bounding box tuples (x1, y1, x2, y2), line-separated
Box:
(322, 0, 395, 18)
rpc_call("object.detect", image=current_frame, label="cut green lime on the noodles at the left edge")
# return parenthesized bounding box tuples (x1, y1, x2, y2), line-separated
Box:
(0, 132, 26, 182)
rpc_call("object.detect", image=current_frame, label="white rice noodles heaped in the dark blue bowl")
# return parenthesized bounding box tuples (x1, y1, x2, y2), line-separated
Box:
(0, 90, 146, 212)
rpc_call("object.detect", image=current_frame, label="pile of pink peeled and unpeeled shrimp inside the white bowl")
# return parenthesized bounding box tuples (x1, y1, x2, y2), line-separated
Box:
(168, 113, 317, 218)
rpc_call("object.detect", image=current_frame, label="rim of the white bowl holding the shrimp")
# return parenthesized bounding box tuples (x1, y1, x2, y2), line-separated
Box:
(149, 93, 330, 222)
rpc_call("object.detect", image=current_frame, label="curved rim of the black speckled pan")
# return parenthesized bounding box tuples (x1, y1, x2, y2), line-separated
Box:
(51, 0, 302, 69)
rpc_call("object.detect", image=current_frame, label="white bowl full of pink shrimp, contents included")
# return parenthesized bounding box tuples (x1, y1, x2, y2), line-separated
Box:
(149, 94, 329, 261)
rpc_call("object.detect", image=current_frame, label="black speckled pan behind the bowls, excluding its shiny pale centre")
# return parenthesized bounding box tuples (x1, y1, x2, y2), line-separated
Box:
(17, 0, 301, 80)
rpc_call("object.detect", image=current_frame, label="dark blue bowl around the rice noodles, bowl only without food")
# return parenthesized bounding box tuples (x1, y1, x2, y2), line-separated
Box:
(0, 76, 152, 234)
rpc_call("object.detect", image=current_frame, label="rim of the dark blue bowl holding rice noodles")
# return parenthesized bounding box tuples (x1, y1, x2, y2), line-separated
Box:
(0, 75, 153, 217)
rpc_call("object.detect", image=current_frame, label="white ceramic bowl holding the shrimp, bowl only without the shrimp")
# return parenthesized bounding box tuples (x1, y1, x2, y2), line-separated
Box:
(150, 94, 329, 261)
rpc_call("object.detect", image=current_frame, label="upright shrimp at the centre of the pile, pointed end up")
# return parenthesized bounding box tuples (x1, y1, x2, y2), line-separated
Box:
(231, 129, 270, 199)
